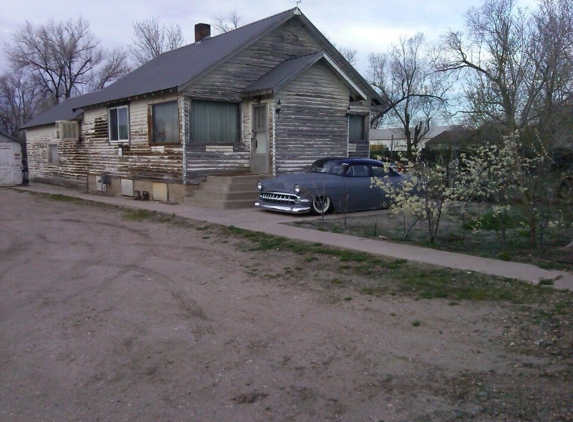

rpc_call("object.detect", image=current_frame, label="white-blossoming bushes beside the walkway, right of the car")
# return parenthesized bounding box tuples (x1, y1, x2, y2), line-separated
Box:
(374, 135, 564, 249)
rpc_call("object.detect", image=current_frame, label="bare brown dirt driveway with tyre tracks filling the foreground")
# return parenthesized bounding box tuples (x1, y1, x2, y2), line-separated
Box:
(0, 189, 573, 421)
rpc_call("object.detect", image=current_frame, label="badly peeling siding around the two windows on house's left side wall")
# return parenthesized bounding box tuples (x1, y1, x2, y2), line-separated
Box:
(83, 95, 185, 183)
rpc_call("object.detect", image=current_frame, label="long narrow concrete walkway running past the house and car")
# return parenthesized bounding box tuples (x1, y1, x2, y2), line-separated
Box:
(13, 184, 573, 290)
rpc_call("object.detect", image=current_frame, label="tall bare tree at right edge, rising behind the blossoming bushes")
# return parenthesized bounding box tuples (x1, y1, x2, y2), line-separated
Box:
(439, 0, 573, 245)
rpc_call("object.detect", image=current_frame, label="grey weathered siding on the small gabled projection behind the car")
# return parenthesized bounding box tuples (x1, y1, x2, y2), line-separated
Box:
(272, 62, 349, 174)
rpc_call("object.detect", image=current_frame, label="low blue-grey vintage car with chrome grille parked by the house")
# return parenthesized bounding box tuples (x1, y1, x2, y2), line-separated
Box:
(255, 158, 405, 214)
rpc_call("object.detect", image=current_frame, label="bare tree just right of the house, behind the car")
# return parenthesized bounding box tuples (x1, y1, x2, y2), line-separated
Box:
(369, 33, 451, 160)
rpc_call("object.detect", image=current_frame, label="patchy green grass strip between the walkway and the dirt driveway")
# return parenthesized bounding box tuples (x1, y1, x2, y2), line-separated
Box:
(222, 223, 571, 308)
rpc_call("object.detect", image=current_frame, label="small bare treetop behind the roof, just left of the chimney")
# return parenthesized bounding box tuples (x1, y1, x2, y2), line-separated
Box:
(129, 16, 185, 66)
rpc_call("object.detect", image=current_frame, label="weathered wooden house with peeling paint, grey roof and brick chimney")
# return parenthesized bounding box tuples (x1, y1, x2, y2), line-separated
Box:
(24, 8, 381, 201)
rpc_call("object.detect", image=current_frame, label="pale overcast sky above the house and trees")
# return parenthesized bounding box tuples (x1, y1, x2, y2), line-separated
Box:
(0, 0, 537, 74)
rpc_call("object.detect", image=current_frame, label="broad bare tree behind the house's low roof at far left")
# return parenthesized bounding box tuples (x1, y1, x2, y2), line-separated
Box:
(6, 17, 127, 104)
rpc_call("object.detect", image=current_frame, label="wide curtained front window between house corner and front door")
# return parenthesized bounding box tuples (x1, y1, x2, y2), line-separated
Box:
(191, 101, 240, 144)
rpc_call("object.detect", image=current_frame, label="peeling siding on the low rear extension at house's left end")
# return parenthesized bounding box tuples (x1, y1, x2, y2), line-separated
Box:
(26, 125, 88, 189)
